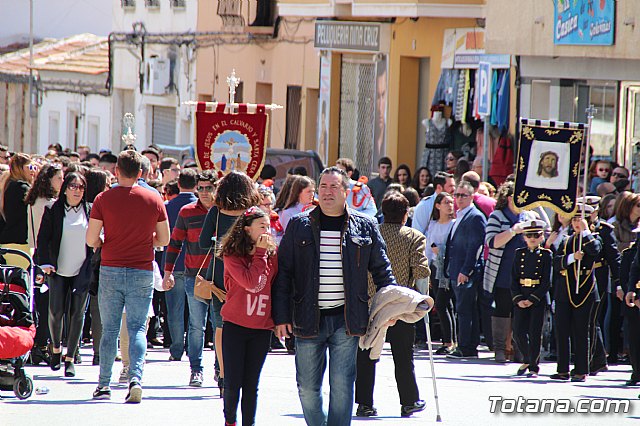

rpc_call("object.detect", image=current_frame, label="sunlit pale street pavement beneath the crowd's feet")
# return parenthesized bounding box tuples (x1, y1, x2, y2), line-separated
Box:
(0, 345, 640, 426)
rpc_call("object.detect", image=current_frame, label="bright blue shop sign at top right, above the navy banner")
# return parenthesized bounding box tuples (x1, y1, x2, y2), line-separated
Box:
(553, 0, 616, 46)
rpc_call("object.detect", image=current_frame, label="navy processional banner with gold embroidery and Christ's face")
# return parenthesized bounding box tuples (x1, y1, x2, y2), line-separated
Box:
(513, 119, 588, 215)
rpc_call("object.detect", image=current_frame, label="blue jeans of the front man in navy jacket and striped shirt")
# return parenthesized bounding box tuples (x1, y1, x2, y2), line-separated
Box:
(296, 315, 358, 426)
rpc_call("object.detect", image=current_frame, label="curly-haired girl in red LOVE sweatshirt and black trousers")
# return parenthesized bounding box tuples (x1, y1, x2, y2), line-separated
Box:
(221, 207, 278, 425)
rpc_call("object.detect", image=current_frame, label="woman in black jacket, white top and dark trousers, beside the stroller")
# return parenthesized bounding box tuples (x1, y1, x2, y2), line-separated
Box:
(35, 173, 93, 377)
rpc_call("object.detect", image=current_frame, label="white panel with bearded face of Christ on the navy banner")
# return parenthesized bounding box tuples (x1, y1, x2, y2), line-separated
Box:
(526, 140, 570, 190)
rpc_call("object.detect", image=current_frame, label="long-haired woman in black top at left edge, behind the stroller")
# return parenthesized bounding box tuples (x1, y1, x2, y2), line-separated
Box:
(0, 153, 38, 269)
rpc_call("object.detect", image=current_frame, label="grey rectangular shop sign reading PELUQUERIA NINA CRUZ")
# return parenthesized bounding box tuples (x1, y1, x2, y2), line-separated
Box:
(313, 21, 384, 52)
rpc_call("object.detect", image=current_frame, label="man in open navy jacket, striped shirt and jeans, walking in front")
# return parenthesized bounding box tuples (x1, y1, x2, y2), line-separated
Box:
(272, 167, 396, 426)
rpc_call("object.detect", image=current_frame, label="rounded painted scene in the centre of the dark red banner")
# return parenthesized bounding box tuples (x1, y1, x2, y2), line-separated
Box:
(211, 130, 251, 173)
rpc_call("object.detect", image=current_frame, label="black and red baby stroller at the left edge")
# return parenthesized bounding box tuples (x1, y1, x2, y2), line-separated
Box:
(0, 248, 36, 399)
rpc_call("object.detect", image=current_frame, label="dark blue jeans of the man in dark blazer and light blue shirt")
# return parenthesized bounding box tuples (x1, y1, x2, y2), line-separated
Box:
(451, 278, 480, 355)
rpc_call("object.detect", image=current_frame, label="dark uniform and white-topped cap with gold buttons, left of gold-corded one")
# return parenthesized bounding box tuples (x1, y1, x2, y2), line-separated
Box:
(511, 220, 553, 374)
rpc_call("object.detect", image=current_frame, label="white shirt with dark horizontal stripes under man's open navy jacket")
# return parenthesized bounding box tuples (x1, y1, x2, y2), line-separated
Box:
(318, 230, 344, 309)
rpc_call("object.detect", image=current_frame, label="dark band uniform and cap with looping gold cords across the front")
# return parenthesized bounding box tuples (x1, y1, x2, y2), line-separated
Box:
(551, 205, 602, 381)
